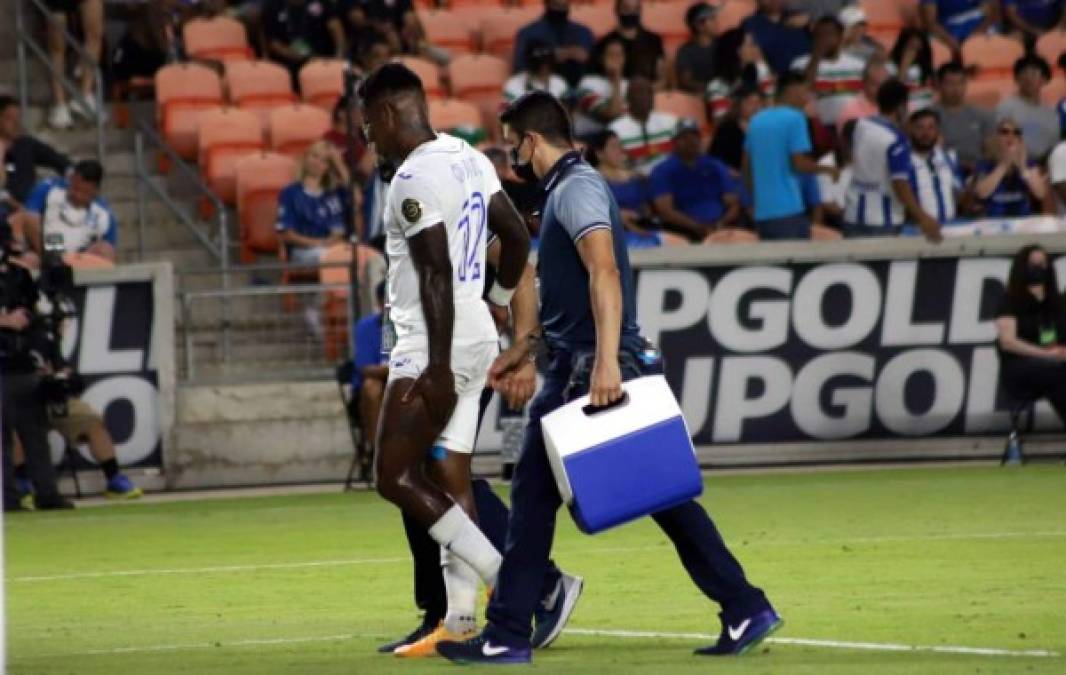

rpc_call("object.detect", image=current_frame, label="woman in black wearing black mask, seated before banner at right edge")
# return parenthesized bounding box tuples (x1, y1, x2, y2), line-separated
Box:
(996, 245, 1066, 421)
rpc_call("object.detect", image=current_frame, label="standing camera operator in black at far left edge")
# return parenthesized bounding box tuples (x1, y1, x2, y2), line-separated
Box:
(0, 222, 74, 511)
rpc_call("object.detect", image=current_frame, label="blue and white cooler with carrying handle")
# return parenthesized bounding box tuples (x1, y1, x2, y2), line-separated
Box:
(540, 375, 704, 534)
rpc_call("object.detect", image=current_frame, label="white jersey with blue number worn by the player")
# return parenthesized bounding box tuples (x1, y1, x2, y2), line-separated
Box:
(385, 133, 501, 347)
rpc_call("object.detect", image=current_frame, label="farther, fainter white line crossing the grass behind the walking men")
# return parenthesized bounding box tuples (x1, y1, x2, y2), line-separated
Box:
(7, 530, 1066, 583)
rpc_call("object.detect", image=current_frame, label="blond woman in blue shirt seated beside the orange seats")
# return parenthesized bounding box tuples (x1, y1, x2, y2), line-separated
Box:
(277, 141, 348, 264)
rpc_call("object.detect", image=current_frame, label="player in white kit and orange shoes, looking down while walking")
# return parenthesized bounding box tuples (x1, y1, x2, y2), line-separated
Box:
(359, 64, 536, 656)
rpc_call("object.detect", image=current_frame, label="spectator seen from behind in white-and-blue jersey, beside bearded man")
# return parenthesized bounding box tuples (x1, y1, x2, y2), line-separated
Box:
(844, 78, 940, 241)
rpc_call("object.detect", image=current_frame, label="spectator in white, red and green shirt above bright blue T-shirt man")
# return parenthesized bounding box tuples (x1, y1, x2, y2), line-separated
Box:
(792, 16, 865, 128)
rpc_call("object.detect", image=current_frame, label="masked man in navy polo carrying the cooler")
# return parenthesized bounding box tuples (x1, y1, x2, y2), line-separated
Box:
(437, 92, 781, 663)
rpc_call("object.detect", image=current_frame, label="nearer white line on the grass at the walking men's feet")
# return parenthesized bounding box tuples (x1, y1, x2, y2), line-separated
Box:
(20, 628, 1061, 658)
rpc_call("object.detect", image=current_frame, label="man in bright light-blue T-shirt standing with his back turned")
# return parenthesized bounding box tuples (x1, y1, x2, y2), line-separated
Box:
(743, 73, 836, 240)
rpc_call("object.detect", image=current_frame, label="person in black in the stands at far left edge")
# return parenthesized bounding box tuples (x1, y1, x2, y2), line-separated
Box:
(0, 95, 70, 208)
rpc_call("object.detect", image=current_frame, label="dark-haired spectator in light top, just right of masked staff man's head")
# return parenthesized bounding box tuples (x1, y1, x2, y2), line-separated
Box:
(572, 39, 629, 139)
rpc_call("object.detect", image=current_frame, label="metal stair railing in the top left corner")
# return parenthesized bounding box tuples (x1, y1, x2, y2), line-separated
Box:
(12, 0, 107, 162)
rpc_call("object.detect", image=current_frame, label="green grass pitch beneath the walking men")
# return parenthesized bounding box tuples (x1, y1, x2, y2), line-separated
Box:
(4, 465, 1066, 675)
